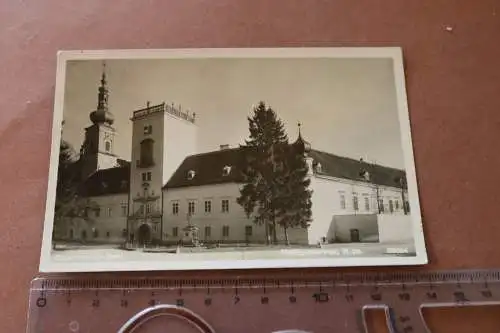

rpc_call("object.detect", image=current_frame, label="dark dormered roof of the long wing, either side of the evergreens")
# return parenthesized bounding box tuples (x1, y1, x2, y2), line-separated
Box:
(164, 148, 405, 188)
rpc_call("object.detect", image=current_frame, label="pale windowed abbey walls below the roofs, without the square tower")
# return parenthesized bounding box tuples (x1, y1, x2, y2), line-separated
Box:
(60, 162, 412, 245)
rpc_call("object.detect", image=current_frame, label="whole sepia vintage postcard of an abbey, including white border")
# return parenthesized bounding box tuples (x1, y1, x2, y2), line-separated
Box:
(40, 47, 427, 272)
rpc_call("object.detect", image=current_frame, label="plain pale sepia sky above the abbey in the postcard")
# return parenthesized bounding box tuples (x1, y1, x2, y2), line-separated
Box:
(63, 58, 404, 168)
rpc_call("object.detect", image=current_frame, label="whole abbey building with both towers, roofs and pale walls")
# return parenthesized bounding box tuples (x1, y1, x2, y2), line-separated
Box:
(57, 68, 412, 246)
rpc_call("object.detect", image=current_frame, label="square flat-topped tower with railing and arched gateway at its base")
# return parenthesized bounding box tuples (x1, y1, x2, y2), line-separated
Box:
(128, 102, 198, 244)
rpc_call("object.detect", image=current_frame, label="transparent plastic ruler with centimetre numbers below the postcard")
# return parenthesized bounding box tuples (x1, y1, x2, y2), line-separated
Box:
(27, 270, 500, 333)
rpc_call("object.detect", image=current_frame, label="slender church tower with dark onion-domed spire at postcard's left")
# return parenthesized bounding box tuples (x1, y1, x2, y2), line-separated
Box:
(80, 64, 117, 179)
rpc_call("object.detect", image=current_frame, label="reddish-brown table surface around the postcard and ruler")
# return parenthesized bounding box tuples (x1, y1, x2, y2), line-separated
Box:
(0, 0, 500, 333)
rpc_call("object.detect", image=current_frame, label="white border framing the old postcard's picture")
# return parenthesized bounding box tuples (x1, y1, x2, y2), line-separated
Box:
(39, 47, 428, 272)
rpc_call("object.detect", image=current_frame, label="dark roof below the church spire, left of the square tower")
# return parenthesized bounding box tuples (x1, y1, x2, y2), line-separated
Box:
(81, 163, 130, 196)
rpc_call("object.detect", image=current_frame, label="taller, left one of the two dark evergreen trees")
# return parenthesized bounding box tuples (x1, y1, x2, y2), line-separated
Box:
(237, 101, 288, 244)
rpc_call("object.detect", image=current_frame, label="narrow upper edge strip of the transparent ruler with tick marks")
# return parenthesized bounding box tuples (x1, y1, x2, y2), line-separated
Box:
(30, 269, 500, 292)
